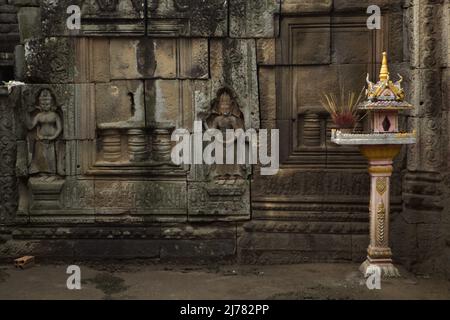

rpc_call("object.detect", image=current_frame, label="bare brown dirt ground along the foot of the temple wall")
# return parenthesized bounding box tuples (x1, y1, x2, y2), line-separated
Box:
(0, 262, 450, 300)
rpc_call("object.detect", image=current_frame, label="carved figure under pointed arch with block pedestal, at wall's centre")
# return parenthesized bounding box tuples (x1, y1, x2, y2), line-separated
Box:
(188, 87, 250, 221)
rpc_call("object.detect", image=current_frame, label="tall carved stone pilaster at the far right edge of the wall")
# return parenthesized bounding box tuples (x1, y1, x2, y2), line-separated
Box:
(398, 0, 448, 269)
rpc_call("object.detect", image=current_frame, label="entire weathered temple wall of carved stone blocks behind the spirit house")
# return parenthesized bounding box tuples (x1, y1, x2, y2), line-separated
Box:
(0, 0, 450, 271)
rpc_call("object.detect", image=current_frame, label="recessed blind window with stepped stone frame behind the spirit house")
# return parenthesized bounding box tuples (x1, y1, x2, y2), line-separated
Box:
(276, 14, 387, 170)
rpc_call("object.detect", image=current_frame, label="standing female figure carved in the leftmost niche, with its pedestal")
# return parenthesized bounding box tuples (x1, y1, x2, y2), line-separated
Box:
(25, 88, 65, 210)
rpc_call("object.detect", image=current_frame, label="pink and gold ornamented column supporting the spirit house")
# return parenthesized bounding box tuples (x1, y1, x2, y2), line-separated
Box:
(361, 145, 401, 277)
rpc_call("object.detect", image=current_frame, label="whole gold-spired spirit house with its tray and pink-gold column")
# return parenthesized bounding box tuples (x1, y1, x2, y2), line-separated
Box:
(331, 52, 416, 277)
